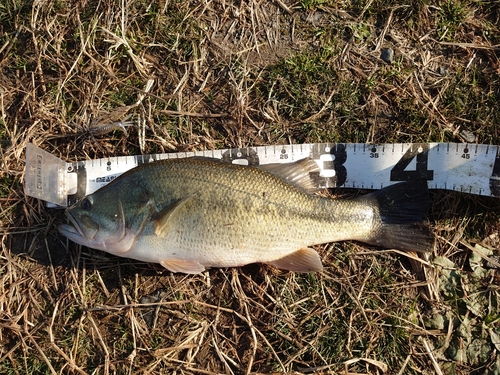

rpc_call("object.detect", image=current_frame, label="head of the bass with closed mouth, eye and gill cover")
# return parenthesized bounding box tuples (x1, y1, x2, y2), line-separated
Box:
(59, 180, 154, 255)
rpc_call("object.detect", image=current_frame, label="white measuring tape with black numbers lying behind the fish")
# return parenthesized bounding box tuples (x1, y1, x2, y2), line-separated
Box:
(25, 143, 500, 207)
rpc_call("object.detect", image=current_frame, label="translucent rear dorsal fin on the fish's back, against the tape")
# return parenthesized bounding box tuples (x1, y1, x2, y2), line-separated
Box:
(259, 158, 322, 194)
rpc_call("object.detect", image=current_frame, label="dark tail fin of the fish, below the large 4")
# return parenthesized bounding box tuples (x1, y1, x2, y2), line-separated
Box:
(359, 181, 434, 252)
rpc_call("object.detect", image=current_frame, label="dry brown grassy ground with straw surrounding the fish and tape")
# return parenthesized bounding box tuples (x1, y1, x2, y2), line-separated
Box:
(0, 0, 500, 374)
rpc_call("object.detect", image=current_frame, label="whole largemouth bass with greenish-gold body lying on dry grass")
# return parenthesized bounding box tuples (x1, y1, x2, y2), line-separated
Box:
(59, 158, 433, 273)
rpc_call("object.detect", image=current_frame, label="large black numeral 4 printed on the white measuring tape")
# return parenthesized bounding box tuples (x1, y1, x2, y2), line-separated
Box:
(391, 143, 434, 181)
